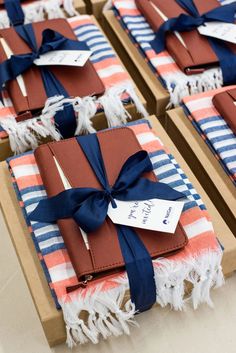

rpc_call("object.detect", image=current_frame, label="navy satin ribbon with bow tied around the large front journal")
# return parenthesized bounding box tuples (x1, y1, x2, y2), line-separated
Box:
(29, 134, 185, 312)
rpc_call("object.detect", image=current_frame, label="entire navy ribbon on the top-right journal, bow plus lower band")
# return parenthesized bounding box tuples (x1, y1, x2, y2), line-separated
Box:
(150, 0, 236, 84)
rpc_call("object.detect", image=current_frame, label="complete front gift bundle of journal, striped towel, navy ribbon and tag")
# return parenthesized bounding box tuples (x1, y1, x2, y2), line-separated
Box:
(8, 120, 223, 346)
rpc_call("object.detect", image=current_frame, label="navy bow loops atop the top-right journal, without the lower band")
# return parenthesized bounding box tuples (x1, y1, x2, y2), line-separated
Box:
(150, 0, 236, 53)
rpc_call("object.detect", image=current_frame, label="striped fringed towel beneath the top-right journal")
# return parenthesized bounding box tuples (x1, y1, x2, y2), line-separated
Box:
(112, 0, 230, 106)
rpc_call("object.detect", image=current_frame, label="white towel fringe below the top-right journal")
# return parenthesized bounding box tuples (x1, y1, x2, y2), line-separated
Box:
(165, 68, 223, 108)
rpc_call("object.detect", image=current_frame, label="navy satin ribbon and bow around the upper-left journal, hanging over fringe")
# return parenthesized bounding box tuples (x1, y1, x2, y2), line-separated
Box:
(0, 24, 88, 138)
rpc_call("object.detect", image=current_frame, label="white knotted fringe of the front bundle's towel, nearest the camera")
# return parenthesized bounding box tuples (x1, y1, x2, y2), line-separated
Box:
(59, 250, 224, 348)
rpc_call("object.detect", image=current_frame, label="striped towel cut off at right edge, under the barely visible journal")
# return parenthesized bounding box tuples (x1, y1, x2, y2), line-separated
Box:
(183, 86, 236, 185)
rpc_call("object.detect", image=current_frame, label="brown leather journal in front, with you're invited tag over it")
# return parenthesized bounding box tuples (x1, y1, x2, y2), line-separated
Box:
(35, 127, 187, 280)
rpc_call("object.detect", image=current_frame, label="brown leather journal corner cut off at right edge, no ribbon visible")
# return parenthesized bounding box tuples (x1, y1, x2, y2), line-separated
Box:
(212, 88, 236, 134)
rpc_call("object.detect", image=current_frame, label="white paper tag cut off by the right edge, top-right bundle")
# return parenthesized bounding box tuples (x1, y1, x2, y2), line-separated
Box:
(198, 21, 236, 44)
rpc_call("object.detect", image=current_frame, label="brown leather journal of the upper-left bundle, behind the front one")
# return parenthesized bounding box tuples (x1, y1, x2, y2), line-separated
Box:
(0, 19, 105, 118)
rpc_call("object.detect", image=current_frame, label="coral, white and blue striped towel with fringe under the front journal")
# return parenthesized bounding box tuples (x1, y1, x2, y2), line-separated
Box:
(8, 120, 223, 347)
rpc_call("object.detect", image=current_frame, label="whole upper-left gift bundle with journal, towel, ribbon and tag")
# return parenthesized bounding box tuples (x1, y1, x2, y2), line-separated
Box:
(0, 15, 146, 153)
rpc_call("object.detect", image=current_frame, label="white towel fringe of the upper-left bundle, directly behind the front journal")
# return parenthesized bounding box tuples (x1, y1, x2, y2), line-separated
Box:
(1, 83, 147, 154)
